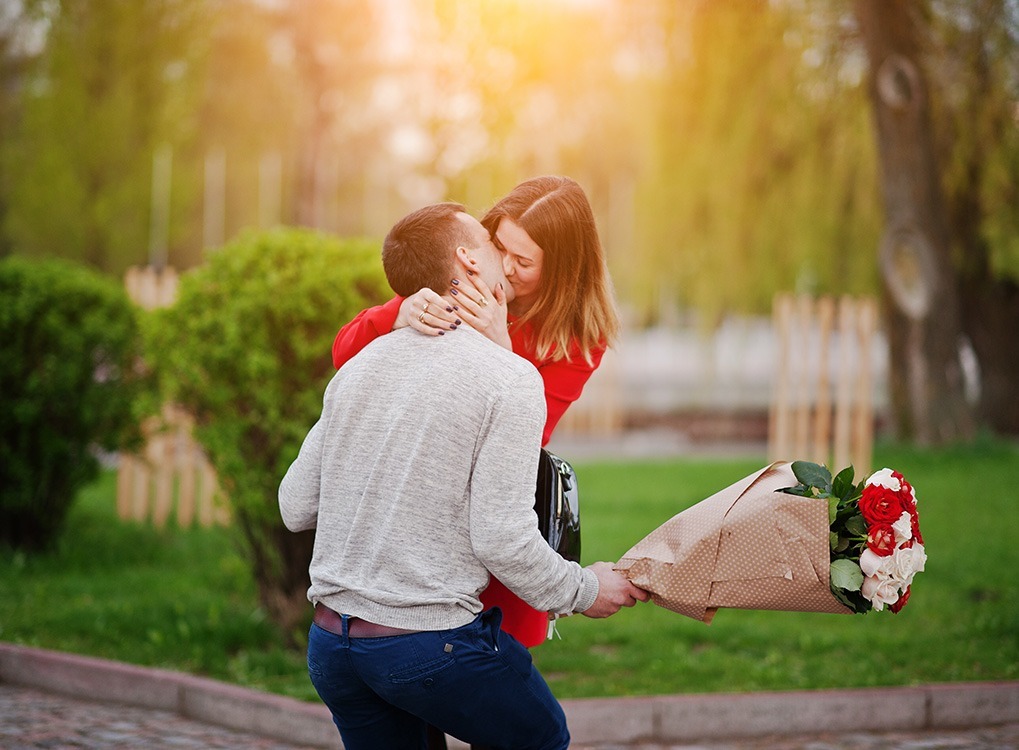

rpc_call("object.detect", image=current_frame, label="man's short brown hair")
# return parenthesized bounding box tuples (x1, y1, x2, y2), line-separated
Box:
(382, 203, 471, 297)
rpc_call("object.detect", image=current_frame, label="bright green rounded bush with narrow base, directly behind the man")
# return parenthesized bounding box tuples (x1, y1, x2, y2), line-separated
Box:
(147, 229, 391, 630)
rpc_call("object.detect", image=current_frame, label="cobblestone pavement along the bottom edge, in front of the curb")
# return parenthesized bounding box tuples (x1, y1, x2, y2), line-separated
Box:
(0, 684, 1019, 750)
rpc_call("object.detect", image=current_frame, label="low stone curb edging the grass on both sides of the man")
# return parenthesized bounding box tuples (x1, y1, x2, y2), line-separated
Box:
(0, 643, 1019, 747)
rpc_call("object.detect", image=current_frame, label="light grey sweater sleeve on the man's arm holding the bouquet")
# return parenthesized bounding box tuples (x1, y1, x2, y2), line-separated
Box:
(470, 371, 598, 613)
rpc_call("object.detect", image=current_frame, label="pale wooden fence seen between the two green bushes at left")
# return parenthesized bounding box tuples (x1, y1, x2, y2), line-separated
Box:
(117, 266, 230, 528)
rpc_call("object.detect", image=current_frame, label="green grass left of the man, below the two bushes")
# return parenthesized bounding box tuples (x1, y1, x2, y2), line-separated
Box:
(0, 472, 317, 700)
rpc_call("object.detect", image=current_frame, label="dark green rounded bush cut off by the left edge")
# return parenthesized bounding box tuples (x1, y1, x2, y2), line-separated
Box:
(0, 258, 145, 549)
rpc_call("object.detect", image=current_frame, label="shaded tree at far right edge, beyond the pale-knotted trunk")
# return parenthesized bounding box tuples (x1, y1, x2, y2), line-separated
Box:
(922, 0, 1019, 435)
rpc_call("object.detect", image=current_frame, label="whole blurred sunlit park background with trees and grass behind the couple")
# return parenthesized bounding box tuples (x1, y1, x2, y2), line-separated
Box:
(0, 0, 1019, 700)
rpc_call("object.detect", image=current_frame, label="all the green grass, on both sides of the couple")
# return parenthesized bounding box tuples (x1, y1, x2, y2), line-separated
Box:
(0, 439, 1019, 700)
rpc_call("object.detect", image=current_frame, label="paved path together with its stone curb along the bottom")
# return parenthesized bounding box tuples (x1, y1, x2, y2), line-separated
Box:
(0, 643, 1019, 750)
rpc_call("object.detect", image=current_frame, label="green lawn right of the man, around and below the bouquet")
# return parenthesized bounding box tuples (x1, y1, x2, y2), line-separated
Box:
(535, 440, 1019, 697)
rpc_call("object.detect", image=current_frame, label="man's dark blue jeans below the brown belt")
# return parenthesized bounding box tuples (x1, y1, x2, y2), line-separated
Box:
(308, 608, 570, 750)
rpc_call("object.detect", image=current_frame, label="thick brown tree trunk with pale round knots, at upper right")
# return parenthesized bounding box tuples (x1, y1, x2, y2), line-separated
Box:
(855, 0, 973, 444)
